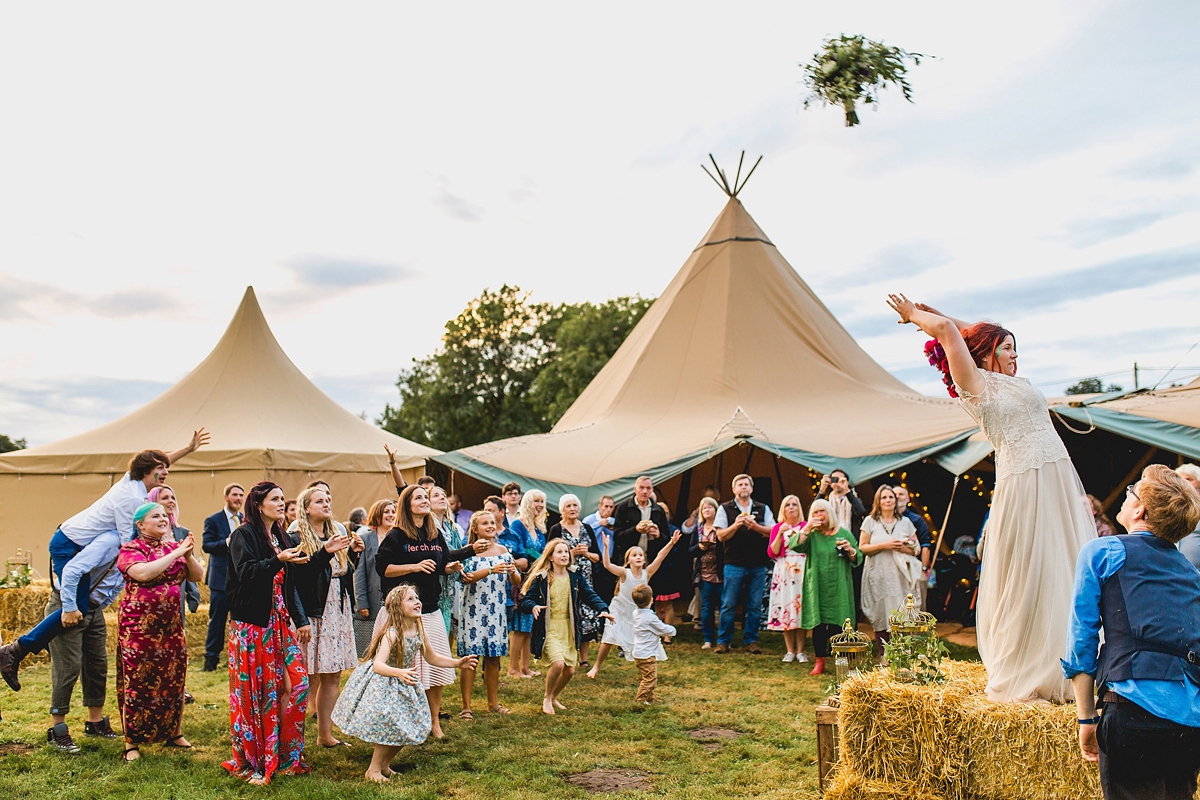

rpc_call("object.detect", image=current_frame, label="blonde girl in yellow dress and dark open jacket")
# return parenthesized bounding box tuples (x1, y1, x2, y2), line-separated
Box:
(521, 539, 613, 715)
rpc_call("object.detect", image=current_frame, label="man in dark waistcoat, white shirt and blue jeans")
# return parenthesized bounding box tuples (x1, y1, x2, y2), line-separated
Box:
(713, 475, 775, 654)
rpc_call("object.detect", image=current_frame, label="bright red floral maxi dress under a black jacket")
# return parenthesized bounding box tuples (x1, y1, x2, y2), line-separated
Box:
(222, 561, 311, 783)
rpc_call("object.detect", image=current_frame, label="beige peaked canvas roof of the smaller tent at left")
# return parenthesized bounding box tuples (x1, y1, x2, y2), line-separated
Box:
(0, 287, 438, 473)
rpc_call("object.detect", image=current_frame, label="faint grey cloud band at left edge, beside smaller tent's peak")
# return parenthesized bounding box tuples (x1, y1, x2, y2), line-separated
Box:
(0, 272, 184, 323)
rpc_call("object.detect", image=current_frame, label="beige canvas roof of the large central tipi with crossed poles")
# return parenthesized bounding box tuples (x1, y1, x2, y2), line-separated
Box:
(434, 198, 976, 503)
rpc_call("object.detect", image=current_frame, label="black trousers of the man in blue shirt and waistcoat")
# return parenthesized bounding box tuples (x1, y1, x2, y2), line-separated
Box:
(1096, 703, 1200, 800)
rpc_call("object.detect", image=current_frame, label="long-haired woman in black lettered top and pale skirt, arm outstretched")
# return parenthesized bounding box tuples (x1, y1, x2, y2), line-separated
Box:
(376, 486, 488, 739)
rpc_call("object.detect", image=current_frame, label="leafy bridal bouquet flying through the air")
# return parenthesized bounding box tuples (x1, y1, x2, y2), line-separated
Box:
(800, 35, 929, 127)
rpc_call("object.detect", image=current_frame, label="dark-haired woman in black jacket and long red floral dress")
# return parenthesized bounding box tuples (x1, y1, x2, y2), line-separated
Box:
(221, 481, 312, 786)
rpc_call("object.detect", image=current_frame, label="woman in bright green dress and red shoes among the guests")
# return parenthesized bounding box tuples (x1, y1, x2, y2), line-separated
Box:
(796, 500, 863, 675)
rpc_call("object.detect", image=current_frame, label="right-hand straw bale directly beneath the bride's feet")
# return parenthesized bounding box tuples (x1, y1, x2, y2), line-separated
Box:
(961, 696, 1100, 800)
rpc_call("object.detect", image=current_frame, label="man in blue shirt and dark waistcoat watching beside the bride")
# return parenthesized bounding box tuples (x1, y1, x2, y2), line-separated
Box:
(1062, 464, 1200, 800)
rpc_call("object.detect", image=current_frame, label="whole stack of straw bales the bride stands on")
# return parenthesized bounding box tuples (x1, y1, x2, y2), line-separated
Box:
(826, 661, 1100, 800)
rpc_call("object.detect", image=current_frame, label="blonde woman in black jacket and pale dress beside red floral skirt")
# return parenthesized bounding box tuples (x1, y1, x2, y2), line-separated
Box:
(288, 486, 362, 747)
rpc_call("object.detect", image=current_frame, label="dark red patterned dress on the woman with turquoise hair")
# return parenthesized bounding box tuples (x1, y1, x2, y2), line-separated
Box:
(116, 536, 187, 745)
